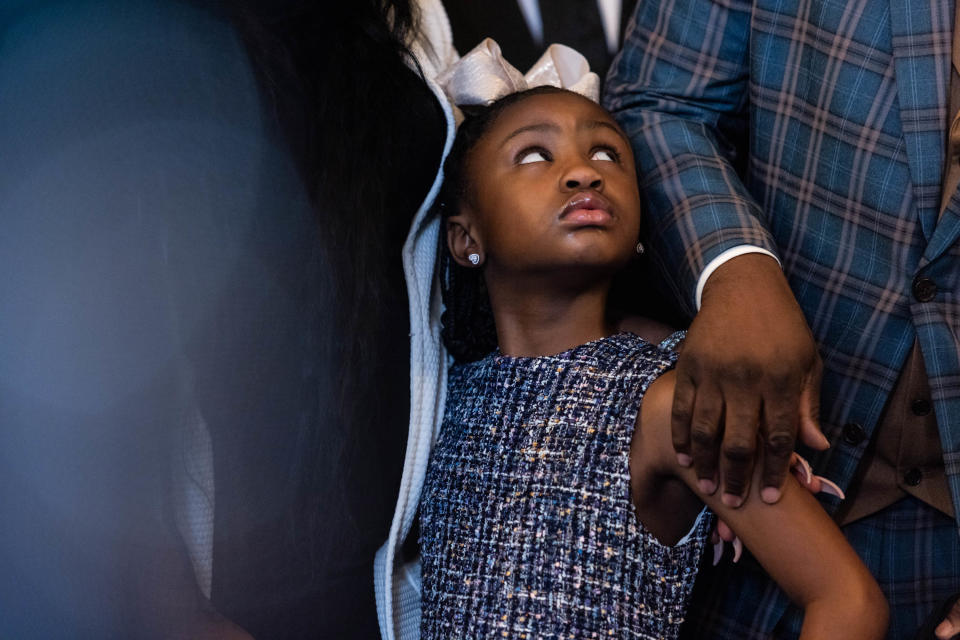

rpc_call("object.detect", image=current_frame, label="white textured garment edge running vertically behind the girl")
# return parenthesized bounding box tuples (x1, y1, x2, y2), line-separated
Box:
(374, 0, 459, 640)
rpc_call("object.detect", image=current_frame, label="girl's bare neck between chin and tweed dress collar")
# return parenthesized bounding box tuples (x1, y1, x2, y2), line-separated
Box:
(489, 278, 613, 357)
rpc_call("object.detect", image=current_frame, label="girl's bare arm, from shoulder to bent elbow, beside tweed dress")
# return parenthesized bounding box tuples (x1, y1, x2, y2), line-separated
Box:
(630, 372, 888, 640)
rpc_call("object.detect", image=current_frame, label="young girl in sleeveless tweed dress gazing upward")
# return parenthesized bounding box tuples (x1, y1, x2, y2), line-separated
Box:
(420, 87, 887, 639)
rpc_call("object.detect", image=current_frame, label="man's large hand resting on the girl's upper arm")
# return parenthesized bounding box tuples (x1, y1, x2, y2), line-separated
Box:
(672, 253, 829, 507)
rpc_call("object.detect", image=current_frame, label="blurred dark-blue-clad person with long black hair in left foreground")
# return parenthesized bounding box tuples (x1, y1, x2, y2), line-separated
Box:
(0, 0, 444, 638)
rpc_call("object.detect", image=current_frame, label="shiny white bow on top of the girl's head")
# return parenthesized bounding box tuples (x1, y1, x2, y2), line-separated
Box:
(437, 38, 600, 123)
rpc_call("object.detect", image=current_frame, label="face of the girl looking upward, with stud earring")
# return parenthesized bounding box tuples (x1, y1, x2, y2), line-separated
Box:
(448, 93, 640, 277)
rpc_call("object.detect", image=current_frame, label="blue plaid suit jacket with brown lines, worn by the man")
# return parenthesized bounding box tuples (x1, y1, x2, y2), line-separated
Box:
(605, 0, 960, 632)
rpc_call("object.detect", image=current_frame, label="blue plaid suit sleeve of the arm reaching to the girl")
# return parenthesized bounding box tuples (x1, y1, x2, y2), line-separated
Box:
(604, 0, 777, 315)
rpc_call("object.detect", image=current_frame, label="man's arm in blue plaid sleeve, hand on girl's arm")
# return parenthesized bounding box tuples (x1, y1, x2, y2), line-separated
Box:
(606, 0, 827, 505)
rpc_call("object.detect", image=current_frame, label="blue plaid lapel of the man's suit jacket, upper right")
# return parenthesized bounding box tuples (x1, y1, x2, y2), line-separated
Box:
(890, 0, 953, 241)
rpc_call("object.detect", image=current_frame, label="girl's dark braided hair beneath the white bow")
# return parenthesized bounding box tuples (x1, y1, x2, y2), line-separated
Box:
(435, 86, 566, 362)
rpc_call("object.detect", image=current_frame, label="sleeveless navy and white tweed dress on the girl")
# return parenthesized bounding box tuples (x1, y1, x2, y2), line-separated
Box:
(420, 333, 712, 640)
